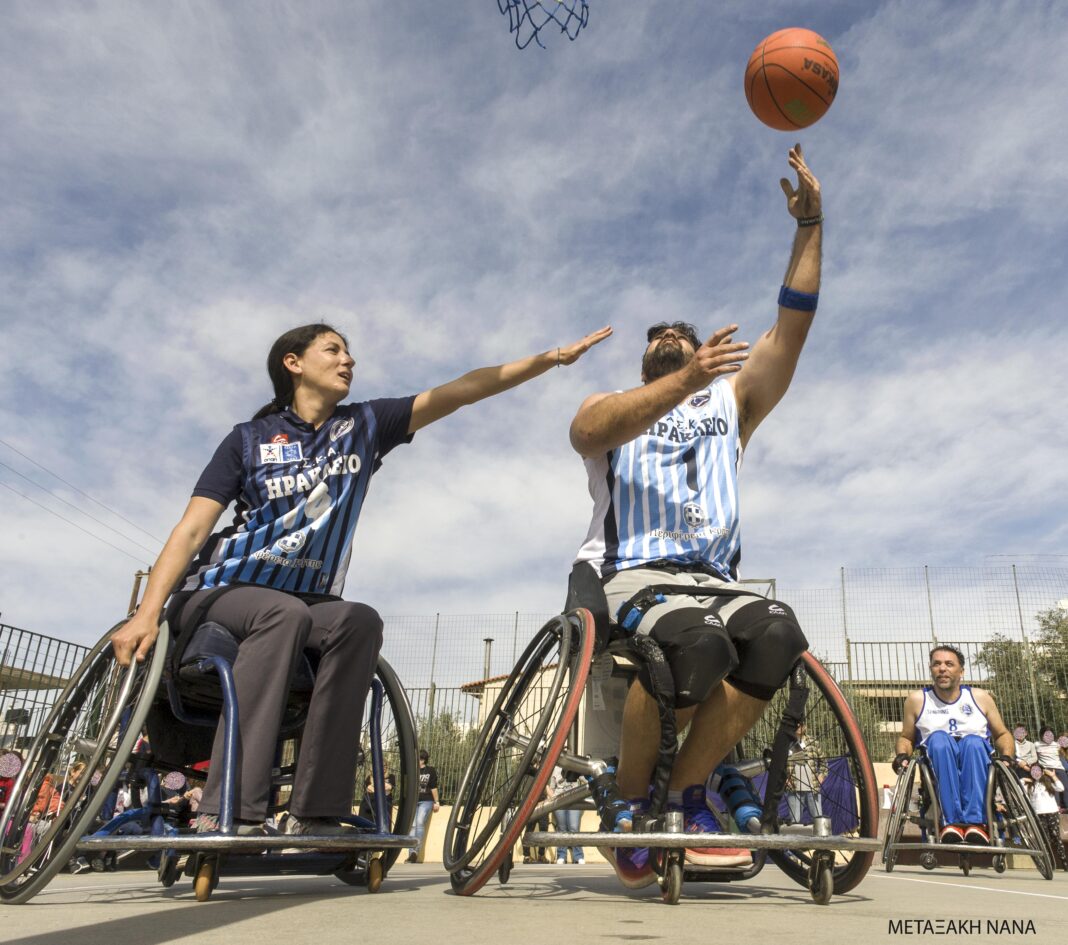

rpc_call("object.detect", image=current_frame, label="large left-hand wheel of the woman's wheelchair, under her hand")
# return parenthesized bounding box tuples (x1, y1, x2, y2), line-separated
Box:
(0, 621, 169, 904)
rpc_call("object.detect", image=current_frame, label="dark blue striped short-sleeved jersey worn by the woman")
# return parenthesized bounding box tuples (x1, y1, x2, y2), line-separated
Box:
(182, 396, 414, 595)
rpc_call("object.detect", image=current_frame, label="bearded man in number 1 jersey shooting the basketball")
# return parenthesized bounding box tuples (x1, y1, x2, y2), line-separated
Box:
(570, 144, 823, 887)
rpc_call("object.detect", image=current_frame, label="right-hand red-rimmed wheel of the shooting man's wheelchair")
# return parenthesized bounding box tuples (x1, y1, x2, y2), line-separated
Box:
(740, 652, 879, 893)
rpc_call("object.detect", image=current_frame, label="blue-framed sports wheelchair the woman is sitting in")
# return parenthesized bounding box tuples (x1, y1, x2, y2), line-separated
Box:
(0, 620, 419, 904)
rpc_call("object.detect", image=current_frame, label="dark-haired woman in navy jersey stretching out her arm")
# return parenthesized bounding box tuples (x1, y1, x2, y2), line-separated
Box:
(112, 324, 611, 834)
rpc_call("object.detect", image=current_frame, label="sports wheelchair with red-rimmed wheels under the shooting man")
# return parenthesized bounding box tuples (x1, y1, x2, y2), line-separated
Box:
(443, 593, 879, 904)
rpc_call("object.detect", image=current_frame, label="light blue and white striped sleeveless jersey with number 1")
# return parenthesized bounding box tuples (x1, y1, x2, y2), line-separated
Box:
(577, 378, 742, 580)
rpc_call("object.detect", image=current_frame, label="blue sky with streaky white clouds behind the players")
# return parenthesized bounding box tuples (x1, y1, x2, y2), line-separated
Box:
(0, 0, 1068, 642)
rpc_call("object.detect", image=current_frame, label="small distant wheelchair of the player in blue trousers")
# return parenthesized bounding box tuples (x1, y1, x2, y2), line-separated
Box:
(882, 747, 1053, 880)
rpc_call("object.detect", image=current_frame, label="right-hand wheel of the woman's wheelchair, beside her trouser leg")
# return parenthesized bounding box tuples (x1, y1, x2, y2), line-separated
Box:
(355, 657, 419, 876)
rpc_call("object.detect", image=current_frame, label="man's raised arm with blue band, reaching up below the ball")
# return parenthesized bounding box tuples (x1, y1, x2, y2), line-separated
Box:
(732, 144, 823, 445)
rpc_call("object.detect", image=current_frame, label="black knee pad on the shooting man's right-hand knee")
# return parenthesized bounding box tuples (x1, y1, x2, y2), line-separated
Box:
(727, 600, 808, 702)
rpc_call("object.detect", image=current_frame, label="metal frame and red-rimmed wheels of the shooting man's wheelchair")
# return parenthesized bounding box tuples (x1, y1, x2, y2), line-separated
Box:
(444, 609, 879, 903)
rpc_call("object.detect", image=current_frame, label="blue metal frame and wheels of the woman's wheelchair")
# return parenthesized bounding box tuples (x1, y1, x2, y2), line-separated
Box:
(0, 620, 418, 904)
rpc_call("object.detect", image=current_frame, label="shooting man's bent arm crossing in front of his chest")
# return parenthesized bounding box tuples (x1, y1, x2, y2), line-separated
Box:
(571, 325, 749, 456)
